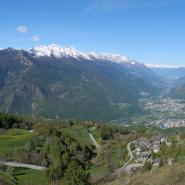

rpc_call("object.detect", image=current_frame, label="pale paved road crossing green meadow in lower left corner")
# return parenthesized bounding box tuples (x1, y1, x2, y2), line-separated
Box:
(0, 161, 47, 171)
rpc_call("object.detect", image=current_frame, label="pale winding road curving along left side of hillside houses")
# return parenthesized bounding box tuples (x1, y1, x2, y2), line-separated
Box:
(113, 142, 143, 177)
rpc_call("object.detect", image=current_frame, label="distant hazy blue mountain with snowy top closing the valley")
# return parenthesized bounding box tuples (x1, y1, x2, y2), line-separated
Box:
(146, 64, 185, 80)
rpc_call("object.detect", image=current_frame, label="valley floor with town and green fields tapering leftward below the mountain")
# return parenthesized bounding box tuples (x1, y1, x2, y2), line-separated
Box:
(110, 96, 185, 129)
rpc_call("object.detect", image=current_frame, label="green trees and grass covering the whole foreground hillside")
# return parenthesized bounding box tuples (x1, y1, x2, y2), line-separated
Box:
(0, 113, 185, 185)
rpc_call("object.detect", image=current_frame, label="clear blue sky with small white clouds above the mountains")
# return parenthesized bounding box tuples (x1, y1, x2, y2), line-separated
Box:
(0, 0, 185, 65)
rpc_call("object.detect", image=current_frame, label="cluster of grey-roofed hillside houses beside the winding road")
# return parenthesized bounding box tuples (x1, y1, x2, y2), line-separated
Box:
(133, 135, 172, 167)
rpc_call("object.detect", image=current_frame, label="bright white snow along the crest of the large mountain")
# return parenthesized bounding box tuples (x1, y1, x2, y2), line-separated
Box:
(30, 44, 138, 65)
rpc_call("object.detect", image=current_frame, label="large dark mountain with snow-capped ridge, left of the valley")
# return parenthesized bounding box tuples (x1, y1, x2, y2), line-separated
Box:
(0, 45, 160, 120)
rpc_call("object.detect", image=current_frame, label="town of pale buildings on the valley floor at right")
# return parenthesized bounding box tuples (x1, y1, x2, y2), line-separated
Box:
(137, 96, 185, 129)
